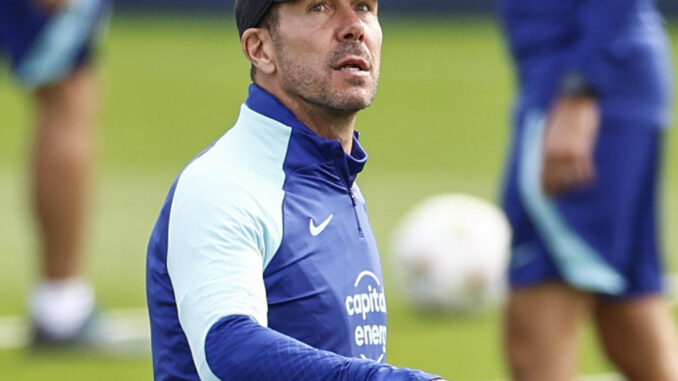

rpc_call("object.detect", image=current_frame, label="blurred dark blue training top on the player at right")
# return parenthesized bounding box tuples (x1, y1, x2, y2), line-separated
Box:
(498, 0, 672, 127)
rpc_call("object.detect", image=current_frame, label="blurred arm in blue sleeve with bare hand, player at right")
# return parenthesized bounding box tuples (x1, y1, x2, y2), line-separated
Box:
(542, 0, 638, 195)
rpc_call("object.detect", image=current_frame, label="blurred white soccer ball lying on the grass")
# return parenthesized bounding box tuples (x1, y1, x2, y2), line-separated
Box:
(392, 194, 511, 313)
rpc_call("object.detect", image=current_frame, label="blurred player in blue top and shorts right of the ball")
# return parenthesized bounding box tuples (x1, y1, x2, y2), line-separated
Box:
(499, 0, 678, 381)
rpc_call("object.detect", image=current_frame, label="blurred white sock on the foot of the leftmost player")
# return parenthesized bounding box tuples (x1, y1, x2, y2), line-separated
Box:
(30, 278, 94, 339)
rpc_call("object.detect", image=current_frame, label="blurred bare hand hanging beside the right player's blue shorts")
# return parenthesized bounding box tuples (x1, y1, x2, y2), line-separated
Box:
(541, 96, 600, 196)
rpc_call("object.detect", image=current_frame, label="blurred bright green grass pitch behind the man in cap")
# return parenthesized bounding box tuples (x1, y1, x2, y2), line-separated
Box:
(0, 15, 678, 380)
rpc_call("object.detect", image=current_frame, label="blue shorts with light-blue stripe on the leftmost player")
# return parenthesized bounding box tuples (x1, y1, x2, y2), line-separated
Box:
(0, 0, 110, 87)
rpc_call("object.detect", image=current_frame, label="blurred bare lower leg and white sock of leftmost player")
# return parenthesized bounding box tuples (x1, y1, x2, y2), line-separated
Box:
(31, 65, 98, 341)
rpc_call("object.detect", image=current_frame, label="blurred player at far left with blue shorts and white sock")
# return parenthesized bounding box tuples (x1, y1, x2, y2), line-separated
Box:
(0, 0, 108, 345)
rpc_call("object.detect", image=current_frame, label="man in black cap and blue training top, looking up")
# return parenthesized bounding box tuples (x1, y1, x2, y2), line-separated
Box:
(147, 0, 446, 380)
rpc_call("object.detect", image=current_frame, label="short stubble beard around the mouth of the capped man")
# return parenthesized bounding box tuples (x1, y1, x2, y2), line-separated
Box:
(273, 37, 379, 115)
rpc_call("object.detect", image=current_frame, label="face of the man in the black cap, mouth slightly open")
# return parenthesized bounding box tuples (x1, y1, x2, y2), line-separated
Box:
(272, 0, 382, 112)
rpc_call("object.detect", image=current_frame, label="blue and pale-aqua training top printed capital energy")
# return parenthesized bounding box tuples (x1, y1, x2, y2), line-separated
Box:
(147, 85, 436, 381)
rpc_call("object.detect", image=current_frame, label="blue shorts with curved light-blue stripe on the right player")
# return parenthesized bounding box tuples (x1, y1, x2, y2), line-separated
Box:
(503, 112, 663, 299)
